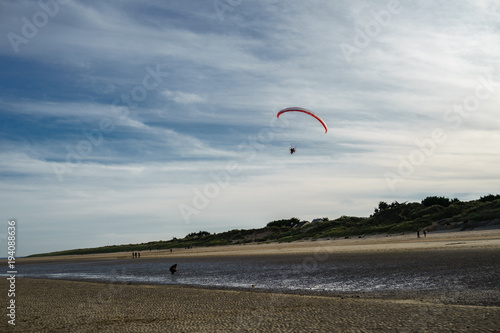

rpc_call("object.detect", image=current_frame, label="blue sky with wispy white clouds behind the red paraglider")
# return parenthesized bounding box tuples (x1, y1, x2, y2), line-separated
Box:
(0, 0, 500, 257)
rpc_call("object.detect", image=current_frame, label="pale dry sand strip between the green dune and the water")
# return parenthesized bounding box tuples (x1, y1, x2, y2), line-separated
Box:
(15, 228, 500, 262)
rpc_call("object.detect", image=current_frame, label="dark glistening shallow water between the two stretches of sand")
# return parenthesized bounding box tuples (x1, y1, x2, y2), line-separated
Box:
(7, 249, 500, 302)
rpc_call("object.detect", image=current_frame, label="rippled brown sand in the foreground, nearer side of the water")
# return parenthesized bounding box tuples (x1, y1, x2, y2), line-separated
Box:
(0, 279, 500, 332)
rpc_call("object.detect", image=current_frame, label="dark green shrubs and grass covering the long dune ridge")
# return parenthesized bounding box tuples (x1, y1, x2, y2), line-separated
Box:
(30, 194, 500, 257)
